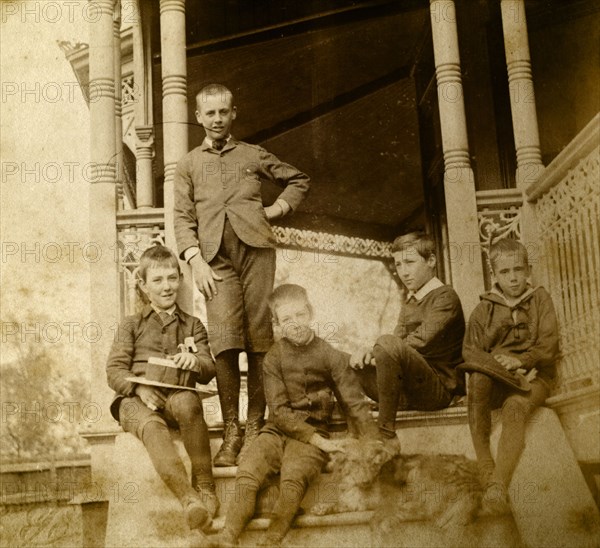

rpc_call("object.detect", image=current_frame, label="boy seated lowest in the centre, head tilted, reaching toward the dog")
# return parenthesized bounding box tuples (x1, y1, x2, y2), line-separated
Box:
(212, 284, 377, 547)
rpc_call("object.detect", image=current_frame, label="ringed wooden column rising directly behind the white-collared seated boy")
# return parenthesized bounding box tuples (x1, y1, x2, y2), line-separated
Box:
(430, 0, 484, 316)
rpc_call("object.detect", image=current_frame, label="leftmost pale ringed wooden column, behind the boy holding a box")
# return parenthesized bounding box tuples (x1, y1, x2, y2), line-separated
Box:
(84, 0, 119, 432)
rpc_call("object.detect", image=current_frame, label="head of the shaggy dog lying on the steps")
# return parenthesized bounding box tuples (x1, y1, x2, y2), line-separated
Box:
(332, 439, 395, 487)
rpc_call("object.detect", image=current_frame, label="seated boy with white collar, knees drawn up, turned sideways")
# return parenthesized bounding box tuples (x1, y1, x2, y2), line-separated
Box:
(350, 232, 465, 445)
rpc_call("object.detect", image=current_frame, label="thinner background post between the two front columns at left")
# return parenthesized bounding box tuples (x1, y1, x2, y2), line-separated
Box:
(133, 0, 154, 208)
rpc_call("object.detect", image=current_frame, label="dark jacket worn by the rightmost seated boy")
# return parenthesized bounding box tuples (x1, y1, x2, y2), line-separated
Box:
(463, 287, 559, 386)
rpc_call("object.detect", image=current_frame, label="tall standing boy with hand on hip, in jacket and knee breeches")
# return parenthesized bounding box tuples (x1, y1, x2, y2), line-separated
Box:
(174, 84, 310, 466)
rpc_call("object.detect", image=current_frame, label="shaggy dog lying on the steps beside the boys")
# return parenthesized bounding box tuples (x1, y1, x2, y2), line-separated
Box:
(311, 439, 482, 546)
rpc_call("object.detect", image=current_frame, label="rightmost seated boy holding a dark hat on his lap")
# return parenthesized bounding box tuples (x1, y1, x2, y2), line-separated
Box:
(461, 239, 558, 512)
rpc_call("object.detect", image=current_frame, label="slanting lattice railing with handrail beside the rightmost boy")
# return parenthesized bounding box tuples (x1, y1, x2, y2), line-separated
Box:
(527, 115, 600, 395)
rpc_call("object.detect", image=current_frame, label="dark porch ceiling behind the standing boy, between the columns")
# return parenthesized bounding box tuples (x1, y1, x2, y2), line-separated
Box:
(154, 0, 429, 238)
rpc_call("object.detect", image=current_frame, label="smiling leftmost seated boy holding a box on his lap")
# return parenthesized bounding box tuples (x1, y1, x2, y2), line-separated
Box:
(106, 245, 219, 529)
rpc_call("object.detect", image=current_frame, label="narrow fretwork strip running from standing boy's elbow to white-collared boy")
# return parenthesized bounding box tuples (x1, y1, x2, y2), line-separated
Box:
(273, 226, 392, 259)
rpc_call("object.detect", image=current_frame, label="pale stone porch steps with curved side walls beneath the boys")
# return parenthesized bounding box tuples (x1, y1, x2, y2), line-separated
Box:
(101, 408, 600, 547)
